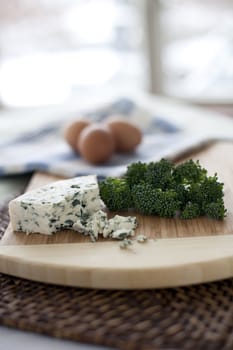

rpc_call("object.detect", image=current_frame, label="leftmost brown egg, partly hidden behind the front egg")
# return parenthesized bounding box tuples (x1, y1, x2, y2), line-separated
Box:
(64, 119, 91, 152)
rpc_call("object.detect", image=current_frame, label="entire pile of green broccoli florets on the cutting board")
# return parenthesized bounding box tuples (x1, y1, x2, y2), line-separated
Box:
(100, 159, 226, 219)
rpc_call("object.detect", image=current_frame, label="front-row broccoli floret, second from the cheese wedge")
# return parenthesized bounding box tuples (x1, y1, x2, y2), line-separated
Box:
(132, 182, 156, 215)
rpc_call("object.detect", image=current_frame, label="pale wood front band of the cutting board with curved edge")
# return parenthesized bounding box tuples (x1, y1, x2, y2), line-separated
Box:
(0, 235, 233, 289)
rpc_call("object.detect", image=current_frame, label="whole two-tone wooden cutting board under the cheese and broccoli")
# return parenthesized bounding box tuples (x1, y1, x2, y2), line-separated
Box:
(0, 142, 233, 289)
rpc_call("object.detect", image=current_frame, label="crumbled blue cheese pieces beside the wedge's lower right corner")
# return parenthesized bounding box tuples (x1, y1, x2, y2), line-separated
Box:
(73, 210, 137, 241)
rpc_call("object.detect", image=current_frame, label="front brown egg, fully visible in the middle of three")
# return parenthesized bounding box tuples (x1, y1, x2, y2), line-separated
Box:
(78, 124, 114, 164)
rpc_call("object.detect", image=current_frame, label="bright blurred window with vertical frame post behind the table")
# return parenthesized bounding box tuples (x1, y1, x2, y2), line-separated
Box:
(0, 0, 233, 111)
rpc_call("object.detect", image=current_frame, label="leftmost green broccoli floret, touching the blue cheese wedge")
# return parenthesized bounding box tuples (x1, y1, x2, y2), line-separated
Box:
(99, 177, 132, 211)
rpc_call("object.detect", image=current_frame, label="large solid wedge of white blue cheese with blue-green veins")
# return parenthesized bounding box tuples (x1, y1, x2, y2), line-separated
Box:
(9, 175, 102, 235)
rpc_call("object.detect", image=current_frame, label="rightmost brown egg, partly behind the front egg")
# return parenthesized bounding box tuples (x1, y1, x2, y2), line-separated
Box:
(106, 117, 142, 152)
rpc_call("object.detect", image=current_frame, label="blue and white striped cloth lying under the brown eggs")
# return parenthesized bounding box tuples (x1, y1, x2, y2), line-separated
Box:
(0, 98, 208, 177)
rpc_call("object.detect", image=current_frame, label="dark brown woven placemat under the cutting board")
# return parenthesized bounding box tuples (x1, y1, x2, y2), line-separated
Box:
(0, 201, 233, 350)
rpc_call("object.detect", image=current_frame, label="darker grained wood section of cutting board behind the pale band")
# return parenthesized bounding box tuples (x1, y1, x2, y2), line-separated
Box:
(1, 142, 233, 245)
